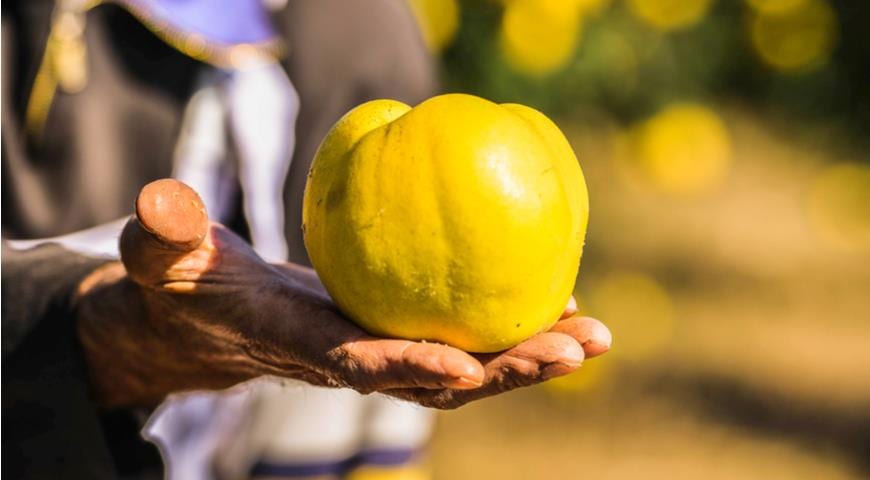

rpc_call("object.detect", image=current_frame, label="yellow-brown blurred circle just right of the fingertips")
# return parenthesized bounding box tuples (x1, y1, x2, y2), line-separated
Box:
(584, 272, 674, 362)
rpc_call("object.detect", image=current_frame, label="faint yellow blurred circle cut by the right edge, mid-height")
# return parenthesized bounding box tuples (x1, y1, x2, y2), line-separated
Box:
(807, 163, 870, 249)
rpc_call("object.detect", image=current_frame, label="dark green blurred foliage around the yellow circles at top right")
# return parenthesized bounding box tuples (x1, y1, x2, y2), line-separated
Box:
(443, 0, 870, 142)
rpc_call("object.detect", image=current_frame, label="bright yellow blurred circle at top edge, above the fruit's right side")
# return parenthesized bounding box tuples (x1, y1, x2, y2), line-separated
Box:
(499, 0, 581, 76)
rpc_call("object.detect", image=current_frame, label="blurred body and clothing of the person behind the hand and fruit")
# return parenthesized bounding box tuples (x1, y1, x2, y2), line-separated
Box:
(3, 0, 612, 478)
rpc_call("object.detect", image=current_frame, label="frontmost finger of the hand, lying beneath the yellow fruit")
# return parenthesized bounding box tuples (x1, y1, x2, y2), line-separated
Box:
(338, 337, 485, 392)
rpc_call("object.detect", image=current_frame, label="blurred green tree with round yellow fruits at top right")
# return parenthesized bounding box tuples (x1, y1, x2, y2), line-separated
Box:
(443, 0, 870, 148)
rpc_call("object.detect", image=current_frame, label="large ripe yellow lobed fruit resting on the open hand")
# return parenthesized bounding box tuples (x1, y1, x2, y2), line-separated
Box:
(302, 94, 589, 352)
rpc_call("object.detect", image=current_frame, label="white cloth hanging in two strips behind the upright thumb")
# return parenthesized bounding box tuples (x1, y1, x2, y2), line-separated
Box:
(173, 63, 299, 261)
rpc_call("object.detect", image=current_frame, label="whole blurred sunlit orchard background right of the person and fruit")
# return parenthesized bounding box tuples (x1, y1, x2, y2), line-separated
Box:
(409, 0, 870, 480)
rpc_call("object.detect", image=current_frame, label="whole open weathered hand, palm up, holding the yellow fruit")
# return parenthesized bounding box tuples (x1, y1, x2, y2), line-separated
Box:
(76, 180, 610, 408)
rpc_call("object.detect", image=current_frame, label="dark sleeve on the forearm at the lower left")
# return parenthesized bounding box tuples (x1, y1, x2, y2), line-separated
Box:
(2, 242, 115, 479)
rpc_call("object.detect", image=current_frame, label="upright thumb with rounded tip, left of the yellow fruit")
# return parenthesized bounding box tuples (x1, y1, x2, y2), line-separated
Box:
(120, 178, 208, 285)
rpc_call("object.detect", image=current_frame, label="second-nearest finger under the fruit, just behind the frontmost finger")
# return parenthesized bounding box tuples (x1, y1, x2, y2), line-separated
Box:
(385, 332, 583, 409)
